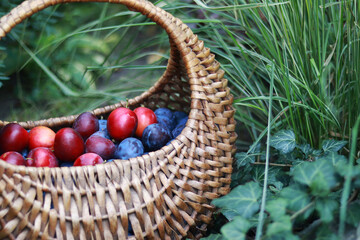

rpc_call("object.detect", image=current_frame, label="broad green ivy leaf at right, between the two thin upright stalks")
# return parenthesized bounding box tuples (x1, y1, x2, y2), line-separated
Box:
(291, 159, 336, 196)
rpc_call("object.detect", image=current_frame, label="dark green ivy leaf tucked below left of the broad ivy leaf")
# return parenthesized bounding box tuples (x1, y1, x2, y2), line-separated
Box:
(280, 185, 313, 218)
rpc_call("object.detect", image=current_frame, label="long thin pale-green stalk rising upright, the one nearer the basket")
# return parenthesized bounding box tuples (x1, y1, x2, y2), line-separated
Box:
(255, 63, 275, 240)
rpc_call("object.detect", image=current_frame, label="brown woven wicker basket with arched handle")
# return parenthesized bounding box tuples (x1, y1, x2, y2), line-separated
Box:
(0, 0, 236, 239)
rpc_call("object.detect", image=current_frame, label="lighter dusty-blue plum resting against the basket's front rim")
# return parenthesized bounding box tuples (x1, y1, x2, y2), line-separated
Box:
(114, 137, 144, 160)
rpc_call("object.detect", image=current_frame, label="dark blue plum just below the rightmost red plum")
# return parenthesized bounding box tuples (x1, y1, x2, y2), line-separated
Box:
(141, 123, 171, 151)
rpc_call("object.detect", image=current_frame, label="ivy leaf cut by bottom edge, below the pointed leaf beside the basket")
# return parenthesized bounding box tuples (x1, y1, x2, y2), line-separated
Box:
(220, 216, 251, 240)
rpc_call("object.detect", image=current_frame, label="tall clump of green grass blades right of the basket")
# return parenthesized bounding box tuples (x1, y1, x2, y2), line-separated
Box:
(183, 0, 360, 147)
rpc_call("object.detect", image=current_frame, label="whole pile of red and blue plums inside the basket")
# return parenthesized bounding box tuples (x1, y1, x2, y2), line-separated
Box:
(0, 107, 188, 167)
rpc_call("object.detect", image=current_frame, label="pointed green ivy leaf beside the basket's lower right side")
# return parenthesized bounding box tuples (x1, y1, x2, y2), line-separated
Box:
(212, 182, 262, 218)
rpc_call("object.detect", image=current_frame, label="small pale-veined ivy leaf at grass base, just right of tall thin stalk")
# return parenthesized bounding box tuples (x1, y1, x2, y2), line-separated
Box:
(270, 130, 296, 154)
